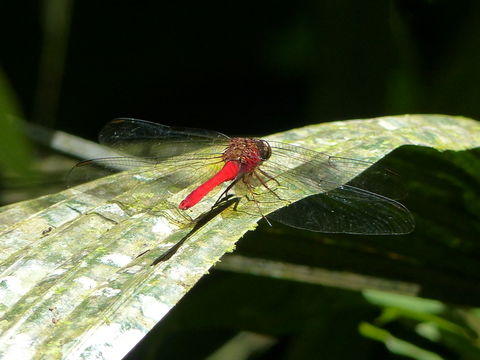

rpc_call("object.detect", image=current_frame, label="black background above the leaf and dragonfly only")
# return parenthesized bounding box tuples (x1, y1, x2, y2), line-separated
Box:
(0, 0, 480, 138)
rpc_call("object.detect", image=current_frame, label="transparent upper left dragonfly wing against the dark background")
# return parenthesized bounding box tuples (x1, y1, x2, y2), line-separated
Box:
(98, 118, 229, 158)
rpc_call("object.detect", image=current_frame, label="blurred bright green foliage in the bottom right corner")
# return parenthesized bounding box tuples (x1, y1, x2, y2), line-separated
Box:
(359, 292, 480, 360)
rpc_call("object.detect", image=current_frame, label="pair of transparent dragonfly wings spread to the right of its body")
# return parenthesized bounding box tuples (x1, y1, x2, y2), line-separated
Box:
(248, 143, 414, 235)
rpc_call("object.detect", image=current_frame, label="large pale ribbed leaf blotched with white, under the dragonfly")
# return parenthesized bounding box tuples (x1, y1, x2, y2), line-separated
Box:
(0, 115, 480, 359)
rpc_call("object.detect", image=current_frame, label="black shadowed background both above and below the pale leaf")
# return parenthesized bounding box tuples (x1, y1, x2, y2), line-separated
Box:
(0, 0, 480, 359)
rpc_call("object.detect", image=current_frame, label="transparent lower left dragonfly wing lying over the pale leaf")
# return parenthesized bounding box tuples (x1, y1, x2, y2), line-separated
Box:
(68, 153, 224, 214)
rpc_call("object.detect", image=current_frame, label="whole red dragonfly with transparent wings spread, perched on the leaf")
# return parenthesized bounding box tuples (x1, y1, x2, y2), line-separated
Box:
(74, 118, 414, 235)
